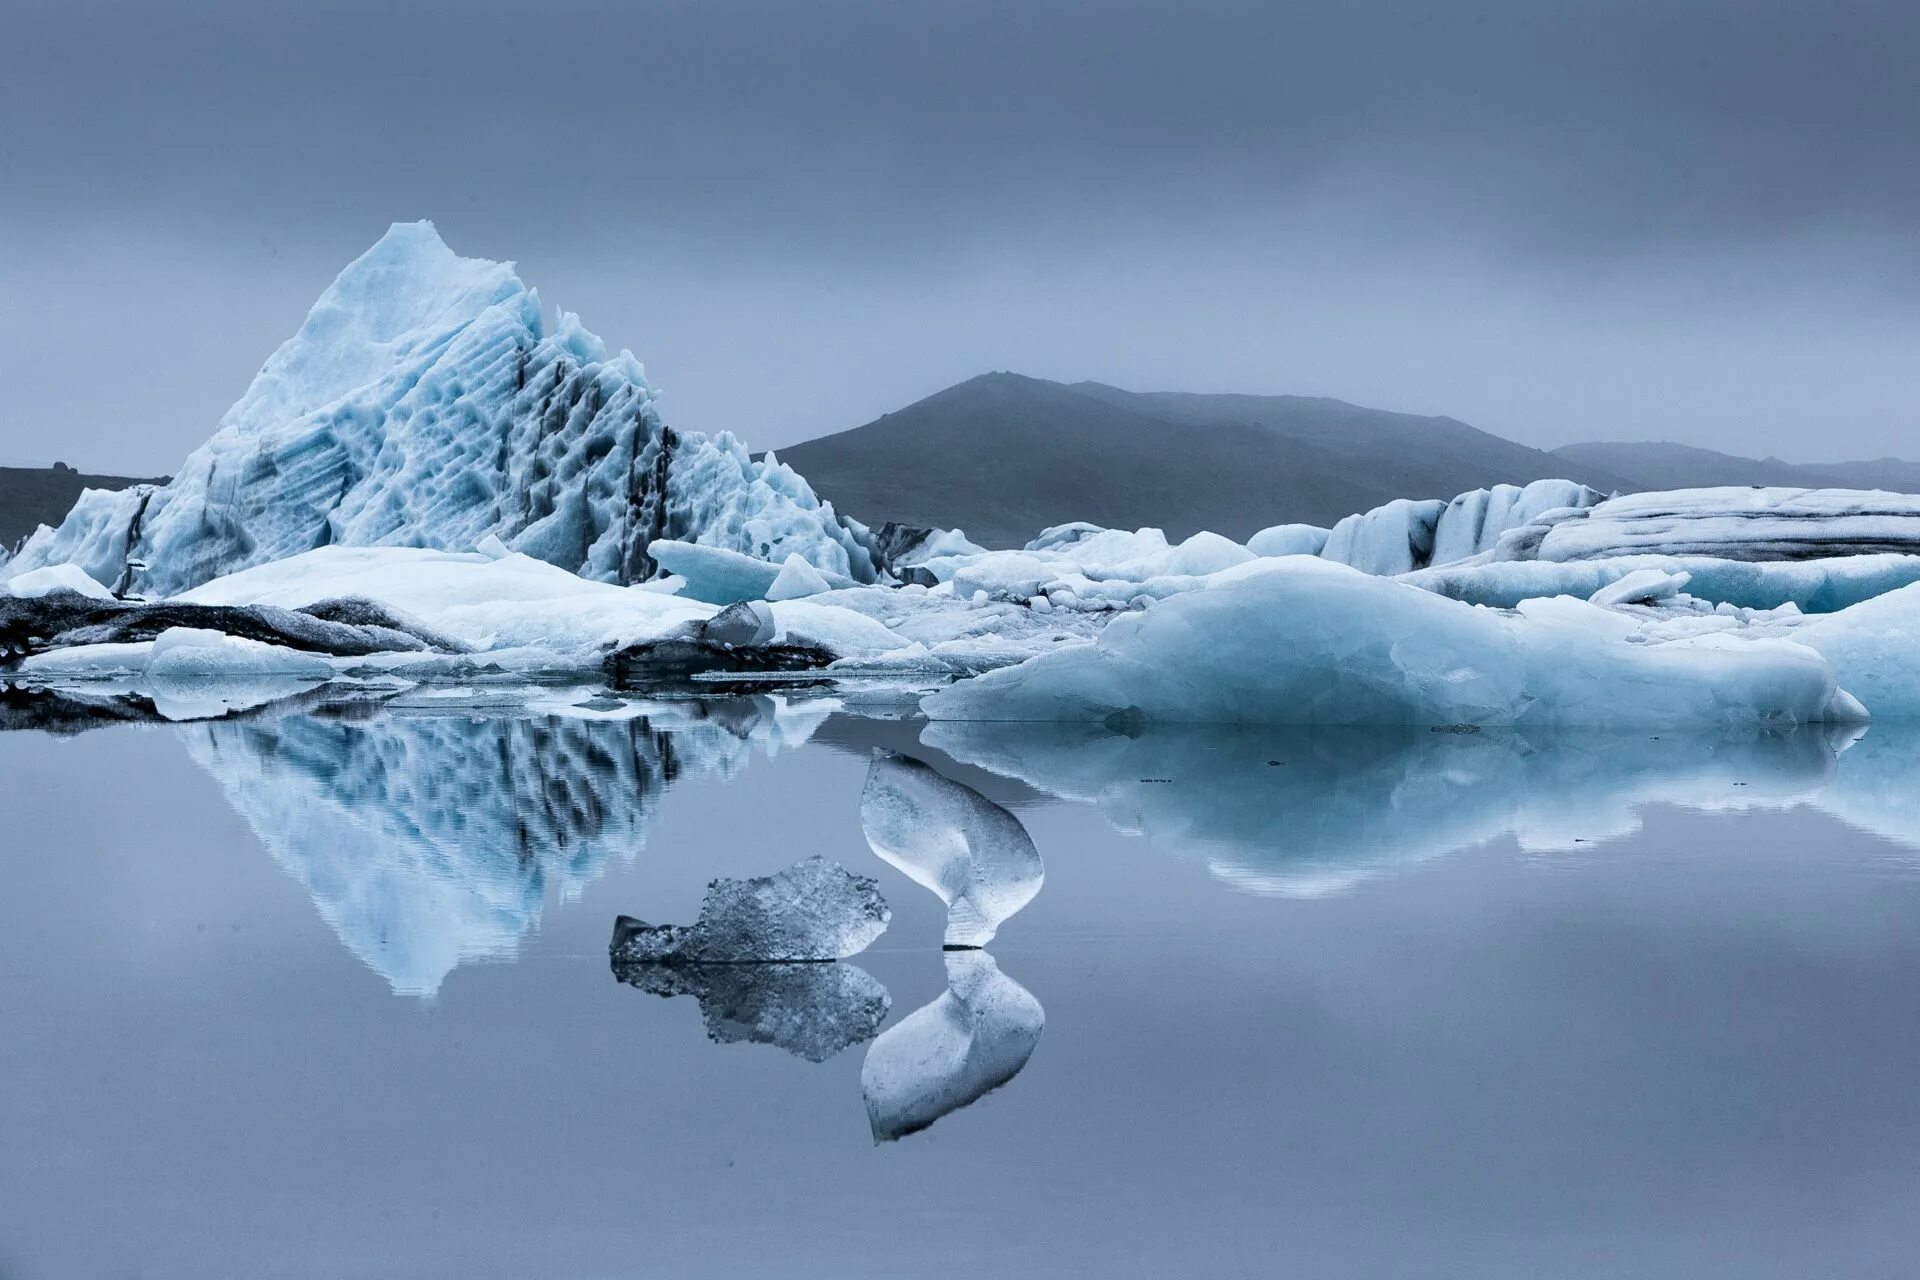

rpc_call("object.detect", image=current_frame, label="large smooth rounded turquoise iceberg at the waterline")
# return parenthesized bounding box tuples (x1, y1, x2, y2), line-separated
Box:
(922, 557, 1859, 727)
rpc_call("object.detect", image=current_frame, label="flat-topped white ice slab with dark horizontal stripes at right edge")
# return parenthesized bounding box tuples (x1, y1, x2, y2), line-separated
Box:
(1528, 487, 1920, 560)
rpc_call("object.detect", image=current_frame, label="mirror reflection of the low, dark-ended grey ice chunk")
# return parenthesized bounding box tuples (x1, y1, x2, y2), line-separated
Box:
(612, 961, 893, 1063)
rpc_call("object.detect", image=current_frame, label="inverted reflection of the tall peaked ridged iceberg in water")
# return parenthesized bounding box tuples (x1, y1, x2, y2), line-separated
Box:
(177, 691, 828, 996)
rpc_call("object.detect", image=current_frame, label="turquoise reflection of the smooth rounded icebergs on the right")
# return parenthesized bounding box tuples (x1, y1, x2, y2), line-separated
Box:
(922, 722, 1920, 896)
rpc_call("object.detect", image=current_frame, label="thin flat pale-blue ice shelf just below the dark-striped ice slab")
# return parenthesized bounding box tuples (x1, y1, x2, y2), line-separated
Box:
(1402, 555, 1920, 614)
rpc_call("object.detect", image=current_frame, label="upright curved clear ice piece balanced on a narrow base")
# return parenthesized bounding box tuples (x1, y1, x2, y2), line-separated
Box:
(860, 752, 1046, 946)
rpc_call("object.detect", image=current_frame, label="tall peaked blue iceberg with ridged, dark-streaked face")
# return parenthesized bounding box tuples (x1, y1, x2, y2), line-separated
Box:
(4, 223, 874, 597)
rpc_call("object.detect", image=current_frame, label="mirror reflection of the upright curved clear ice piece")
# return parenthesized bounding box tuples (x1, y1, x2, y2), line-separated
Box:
(860, 952, 1046, 1142)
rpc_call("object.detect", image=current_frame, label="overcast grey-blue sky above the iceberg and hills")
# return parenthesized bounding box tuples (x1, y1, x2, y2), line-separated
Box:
(0, 0, 1920, 472)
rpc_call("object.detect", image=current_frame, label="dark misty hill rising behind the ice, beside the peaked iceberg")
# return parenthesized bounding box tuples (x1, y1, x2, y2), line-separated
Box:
(780, 372, 1626, 545)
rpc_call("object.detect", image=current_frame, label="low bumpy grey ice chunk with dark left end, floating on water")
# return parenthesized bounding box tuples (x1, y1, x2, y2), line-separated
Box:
(611, 856, 893, 965)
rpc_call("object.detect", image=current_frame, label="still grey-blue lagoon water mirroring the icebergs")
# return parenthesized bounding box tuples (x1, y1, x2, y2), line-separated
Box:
(0, 697, 1920, 1280)
